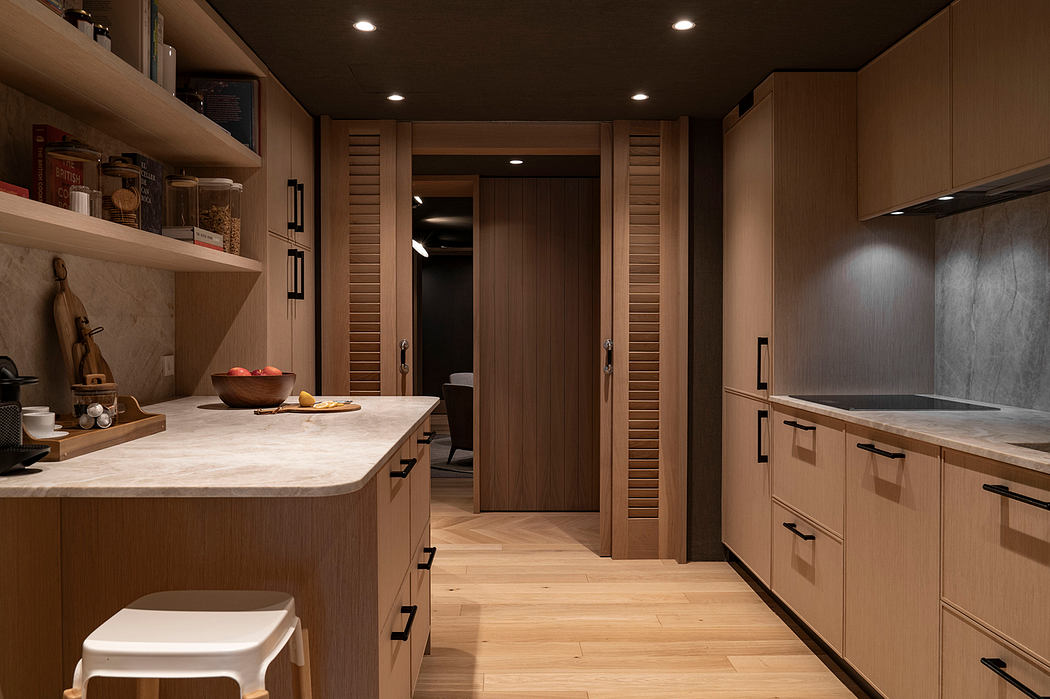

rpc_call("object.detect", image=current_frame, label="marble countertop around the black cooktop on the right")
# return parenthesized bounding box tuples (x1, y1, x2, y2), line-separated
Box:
(770, 396, 1050, 473)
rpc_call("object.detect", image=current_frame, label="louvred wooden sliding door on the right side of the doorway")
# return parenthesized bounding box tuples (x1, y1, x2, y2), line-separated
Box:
(612, 120, 689, 560)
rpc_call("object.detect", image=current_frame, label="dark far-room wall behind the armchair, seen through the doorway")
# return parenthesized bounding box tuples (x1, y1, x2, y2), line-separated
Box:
(419, 255, 474, 397)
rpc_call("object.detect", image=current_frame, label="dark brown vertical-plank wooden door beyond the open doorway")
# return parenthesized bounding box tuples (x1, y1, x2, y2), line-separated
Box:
(475, 177, 601, 511)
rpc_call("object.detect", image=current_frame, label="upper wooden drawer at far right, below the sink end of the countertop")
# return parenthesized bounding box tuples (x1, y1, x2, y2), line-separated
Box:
(942, 450, 1050, 663)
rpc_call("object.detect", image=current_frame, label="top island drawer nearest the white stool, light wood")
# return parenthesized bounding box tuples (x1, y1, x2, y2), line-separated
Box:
(376, 449, 416, 609)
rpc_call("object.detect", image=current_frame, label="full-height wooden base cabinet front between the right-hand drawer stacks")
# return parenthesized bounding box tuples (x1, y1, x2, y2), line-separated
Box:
(843, 425, 941, 699)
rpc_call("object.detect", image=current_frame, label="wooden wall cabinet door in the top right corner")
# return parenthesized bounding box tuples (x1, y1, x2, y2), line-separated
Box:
(950, 0, 1050, 189)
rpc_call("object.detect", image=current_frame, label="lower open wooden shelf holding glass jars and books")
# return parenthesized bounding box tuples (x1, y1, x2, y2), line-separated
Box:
(0, 192, 263, 273)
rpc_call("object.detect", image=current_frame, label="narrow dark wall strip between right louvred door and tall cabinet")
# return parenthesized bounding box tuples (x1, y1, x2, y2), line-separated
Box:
(689, 119, 723, 560)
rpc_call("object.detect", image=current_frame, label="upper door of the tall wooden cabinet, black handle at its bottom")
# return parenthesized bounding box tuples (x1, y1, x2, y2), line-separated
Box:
(722, 94, 773, 398)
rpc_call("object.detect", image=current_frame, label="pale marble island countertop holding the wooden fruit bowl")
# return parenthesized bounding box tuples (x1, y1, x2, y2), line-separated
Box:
(0, 396, 438, 497)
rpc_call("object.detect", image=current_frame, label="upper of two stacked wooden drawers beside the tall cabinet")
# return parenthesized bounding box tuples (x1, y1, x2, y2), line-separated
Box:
(771, 408, 846, 536)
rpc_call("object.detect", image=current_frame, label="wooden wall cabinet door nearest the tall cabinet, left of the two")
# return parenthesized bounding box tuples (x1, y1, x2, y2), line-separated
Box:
(857, 9, 952, 219)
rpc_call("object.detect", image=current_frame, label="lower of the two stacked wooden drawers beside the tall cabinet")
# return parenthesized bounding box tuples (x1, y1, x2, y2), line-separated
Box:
(771, 501, 842, 651)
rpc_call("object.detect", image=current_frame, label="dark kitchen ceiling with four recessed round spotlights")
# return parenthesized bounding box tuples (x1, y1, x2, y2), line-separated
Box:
(211, 0, 947, 121)
